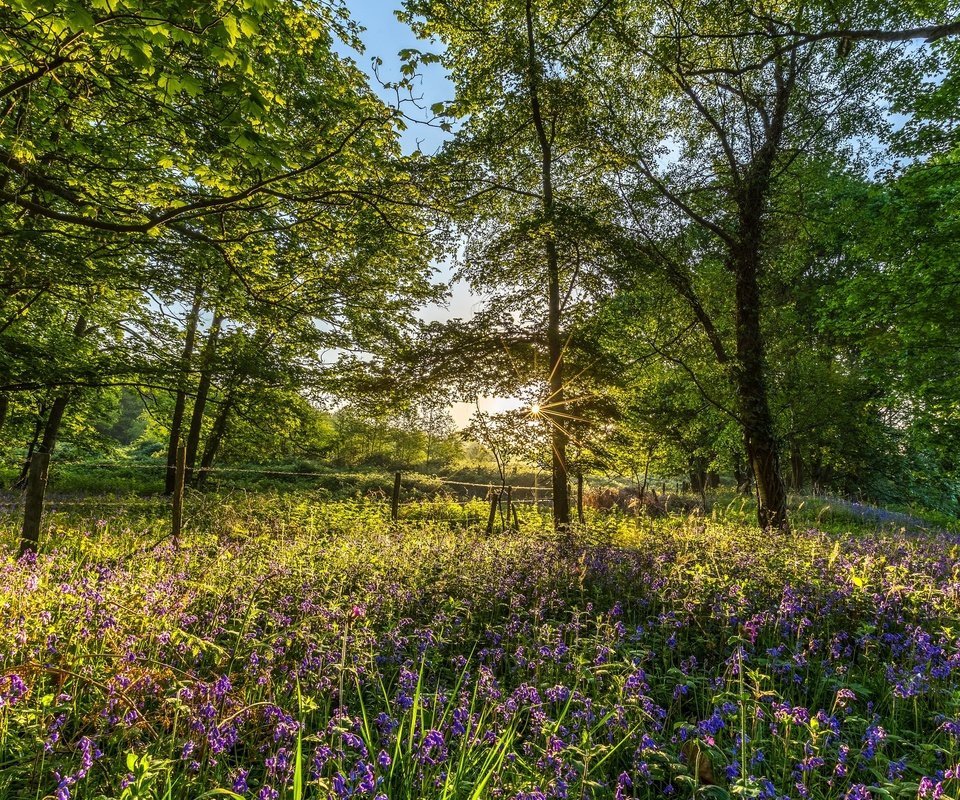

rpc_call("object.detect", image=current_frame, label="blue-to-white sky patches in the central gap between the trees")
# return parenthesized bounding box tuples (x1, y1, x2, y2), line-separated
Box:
(346, 0, 522, 427)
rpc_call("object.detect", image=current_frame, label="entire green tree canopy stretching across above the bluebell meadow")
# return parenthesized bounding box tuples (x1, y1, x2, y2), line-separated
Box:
(0, 0, 960, 529)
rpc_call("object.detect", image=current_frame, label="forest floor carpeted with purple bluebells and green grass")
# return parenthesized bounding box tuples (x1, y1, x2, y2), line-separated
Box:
(0, 492, 960, 800)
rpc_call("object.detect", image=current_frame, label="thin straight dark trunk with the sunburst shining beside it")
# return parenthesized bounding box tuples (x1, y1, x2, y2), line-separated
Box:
(526, 0, 570, 529)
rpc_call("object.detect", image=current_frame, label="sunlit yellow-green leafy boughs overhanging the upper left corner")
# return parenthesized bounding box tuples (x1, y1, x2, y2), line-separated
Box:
(0, 0, 392, 234)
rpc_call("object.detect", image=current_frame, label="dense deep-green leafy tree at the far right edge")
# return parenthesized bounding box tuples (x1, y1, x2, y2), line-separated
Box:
(822, 94, 960, 512)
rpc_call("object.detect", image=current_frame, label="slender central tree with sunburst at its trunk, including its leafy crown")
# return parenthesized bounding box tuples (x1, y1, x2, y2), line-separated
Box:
(403, 0, 620, 527)
